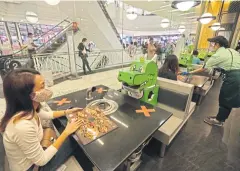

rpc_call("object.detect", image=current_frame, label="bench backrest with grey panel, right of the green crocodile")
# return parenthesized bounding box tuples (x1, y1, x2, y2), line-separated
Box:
(157, 77, 194, 119)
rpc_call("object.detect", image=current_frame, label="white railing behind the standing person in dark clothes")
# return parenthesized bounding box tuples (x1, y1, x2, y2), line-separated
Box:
(33, 50, 143, 79)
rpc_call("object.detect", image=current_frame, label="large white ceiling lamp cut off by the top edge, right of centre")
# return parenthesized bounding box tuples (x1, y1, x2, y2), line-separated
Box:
(172, 0, 201, 11)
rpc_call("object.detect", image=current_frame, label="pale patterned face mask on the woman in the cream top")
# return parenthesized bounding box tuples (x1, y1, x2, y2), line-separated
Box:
(31, 88, 53, 103)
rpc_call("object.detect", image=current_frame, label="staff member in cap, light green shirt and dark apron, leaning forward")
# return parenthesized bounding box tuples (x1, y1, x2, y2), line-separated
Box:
(189, 36, 240, 126)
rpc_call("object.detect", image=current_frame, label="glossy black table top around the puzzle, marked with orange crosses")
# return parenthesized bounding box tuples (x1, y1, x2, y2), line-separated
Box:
(48, 85, 172, 171)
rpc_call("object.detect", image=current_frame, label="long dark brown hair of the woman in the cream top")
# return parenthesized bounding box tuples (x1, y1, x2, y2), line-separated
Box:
(0, 69, 40, 132)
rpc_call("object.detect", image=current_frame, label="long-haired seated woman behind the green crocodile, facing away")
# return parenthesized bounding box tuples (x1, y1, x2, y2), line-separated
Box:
(158, 55, 179, 80)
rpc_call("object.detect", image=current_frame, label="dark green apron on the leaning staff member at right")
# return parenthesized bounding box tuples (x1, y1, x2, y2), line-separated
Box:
(219, 69, 240, 108)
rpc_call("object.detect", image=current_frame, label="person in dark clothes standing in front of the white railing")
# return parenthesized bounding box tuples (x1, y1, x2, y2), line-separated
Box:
(78, 38, 92, 75)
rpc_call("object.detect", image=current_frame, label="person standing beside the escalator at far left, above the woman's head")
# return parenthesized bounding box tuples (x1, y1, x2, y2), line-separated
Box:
(26, 33, 38, 68)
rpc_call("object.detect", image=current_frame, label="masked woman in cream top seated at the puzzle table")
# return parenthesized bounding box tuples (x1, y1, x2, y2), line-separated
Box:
(0, 69, 80, 171)
